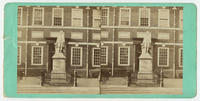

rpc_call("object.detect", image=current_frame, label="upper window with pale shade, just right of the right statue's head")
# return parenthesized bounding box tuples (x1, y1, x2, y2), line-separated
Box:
(158, 9, 169, 27)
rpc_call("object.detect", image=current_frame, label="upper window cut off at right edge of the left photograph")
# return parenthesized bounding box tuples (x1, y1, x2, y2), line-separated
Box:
(93, 10, 101, 27)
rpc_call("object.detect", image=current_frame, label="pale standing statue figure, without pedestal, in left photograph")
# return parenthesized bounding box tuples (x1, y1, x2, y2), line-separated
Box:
(55, 31, 65, 53)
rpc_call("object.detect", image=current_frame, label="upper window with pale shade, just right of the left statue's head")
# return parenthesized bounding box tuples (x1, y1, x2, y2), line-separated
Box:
(72, 8, 83, 27)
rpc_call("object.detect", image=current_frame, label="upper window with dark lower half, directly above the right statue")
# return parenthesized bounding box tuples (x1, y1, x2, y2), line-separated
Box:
(139, 8, 150, 26)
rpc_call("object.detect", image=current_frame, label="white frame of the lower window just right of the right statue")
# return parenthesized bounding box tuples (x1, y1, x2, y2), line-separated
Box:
(157, 47, 169, 67)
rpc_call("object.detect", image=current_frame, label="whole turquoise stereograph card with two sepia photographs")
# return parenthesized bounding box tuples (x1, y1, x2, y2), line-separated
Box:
(4, 3, 196, 97)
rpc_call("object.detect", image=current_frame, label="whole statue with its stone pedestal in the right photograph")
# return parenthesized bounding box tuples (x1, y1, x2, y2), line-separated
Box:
(136, 32, 153, 86)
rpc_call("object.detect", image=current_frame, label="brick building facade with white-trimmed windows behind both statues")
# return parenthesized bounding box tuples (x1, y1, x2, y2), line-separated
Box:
(17, 6, 183, 78)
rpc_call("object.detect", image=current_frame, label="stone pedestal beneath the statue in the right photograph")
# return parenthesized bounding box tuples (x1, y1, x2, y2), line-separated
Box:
(137, 53, 153, 86)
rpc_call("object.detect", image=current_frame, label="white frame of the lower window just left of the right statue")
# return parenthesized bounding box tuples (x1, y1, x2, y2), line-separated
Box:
(118, 46, 130, 66)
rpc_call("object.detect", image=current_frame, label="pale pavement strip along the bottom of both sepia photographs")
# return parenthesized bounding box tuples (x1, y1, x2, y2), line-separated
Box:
(17, 77, 182, 94)
